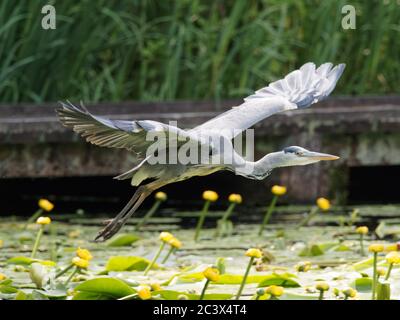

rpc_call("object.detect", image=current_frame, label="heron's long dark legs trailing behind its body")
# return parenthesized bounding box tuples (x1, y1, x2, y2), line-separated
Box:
(95, 186, 154, 241)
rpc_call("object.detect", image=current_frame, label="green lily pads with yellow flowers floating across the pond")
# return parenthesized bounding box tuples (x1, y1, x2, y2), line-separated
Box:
(0, 190, 400, 301)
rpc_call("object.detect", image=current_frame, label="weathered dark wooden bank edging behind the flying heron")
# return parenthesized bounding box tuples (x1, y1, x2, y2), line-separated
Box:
(0, 96, 400, 201)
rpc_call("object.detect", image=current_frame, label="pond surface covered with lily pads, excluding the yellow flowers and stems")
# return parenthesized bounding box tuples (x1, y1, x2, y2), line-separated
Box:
(0, 206, 400, 299)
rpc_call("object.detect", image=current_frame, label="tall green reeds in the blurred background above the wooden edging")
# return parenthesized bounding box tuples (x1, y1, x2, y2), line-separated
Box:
(0, 0, 400, 102)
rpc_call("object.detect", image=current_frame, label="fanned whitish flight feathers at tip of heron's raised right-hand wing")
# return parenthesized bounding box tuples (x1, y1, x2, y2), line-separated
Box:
(245, 62, 345, 108)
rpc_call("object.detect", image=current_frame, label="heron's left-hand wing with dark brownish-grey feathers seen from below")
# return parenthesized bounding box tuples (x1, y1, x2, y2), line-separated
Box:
(56, 103, 198, 157)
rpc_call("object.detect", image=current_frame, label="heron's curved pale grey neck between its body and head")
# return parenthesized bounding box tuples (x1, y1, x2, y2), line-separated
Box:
(231, 151, 288, 179)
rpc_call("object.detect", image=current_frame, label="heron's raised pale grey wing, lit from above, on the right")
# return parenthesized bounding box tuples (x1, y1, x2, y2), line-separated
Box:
(193, 62, 345, 139)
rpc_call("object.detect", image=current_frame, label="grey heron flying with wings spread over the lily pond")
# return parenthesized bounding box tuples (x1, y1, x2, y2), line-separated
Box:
(57, 62, 345, 241)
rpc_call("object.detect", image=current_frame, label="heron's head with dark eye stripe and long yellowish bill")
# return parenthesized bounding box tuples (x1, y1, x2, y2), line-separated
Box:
(280, 146, 339, 167)
